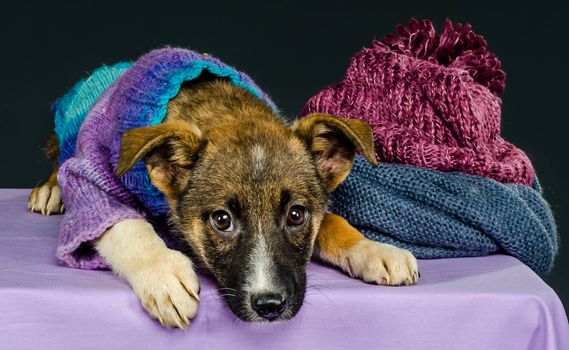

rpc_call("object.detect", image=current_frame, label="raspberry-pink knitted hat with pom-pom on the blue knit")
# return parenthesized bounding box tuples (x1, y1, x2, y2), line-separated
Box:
(301, 19, 535, 185)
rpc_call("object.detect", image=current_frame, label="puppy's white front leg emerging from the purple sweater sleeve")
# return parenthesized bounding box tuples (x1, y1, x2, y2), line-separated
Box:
(96, 219, 199, 328)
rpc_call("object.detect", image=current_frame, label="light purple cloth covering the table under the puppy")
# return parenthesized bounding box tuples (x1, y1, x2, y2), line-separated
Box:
(0, 189, 569, 350)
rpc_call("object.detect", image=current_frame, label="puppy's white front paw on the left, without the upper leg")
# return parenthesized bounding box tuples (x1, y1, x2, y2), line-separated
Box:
(128, 249, 200, 328)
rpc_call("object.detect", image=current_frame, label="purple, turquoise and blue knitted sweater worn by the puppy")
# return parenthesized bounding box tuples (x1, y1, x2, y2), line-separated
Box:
(54, 48, 277, 269)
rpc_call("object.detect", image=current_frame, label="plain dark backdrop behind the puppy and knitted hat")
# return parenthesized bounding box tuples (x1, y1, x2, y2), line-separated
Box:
(0, 0, 569, 305)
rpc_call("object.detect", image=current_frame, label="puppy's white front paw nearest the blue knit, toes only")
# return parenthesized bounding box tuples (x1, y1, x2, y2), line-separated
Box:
(341, 239, 419, 286)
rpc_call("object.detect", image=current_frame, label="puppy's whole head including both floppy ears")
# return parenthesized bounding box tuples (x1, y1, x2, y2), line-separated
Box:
(118, 115, 375, 321)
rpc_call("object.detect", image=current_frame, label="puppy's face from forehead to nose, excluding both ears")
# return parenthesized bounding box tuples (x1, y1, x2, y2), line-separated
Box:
(173, 124, 327, 321)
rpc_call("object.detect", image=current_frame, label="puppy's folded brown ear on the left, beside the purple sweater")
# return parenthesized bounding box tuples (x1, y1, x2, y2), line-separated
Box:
(116, 122, 205, 202)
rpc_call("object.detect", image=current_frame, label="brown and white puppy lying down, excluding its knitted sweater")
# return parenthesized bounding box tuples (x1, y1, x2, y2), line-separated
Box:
(29, 77, 418, 328)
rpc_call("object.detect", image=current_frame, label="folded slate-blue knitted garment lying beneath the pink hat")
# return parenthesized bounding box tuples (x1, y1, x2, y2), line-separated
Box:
(330, 156, 558, 275)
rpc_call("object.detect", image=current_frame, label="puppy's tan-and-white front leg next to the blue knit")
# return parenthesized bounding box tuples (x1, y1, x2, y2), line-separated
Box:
(315, 213, 419, 286)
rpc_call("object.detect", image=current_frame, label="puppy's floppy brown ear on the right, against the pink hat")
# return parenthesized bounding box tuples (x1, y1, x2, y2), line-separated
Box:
(292, 113, 377, 192)
